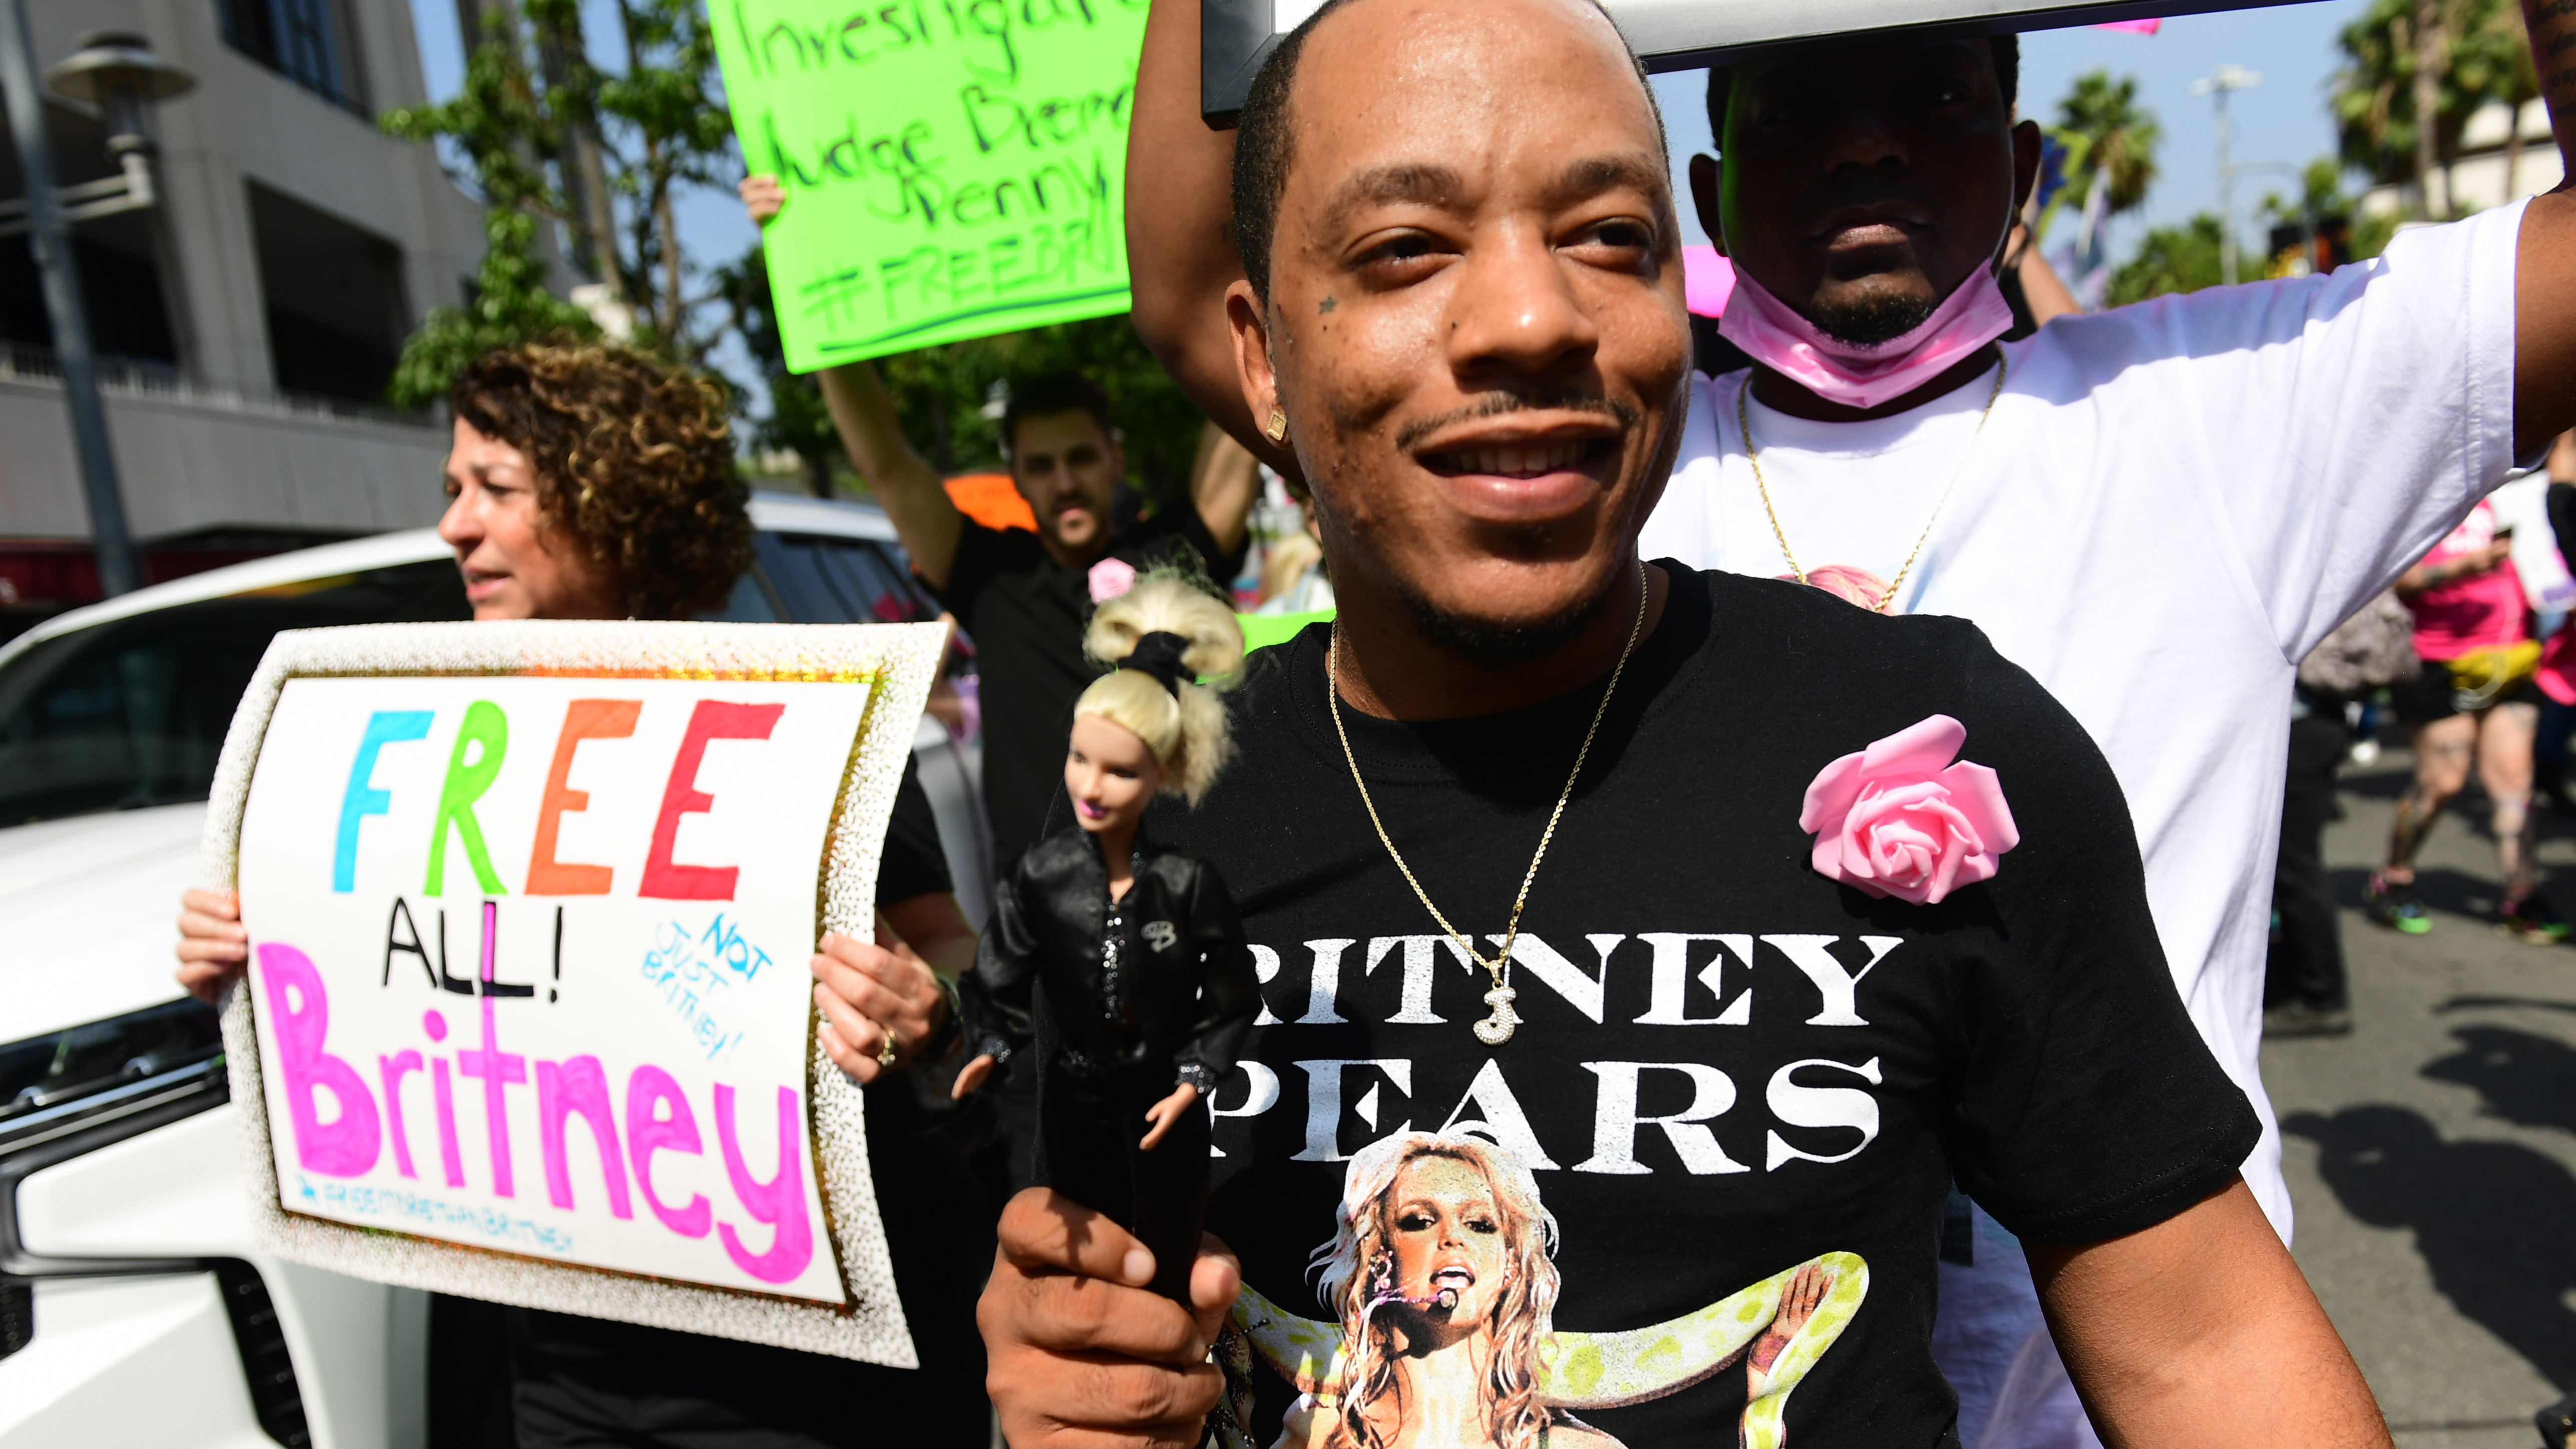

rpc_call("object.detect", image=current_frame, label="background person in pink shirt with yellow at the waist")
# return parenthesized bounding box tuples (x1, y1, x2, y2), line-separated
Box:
(2367, 503, 2568, 943)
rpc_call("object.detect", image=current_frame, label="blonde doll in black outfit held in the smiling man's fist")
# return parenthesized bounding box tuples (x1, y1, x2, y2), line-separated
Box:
(956, 575, 1259, 1305)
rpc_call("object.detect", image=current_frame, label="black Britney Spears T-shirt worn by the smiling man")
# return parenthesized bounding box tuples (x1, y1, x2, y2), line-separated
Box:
(1149, 562, 2257, 1449)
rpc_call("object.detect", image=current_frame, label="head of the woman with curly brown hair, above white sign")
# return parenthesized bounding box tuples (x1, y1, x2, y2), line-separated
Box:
(438, 343, 752, 619)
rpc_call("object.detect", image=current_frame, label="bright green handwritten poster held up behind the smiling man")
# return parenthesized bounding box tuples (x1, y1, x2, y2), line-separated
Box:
(709, 0, 1146, 371)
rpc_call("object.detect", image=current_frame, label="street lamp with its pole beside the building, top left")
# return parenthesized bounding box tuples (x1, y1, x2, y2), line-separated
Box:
(0, 18, 196, 598)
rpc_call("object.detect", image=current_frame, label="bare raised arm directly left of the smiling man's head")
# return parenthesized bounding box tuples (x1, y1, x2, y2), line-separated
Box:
(1126, 0, 1296, 472)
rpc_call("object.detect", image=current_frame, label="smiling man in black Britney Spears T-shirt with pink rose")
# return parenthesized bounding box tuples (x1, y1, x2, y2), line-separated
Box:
(912, 0, 2388, 1449)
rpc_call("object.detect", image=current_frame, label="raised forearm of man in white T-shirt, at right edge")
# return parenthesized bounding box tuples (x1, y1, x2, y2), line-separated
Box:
(2514, 0, 2576, 456)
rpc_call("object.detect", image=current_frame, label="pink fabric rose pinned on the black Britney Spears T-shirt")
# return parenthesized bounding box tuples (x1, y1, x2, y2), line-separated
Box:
(1798, 714, 2022, 905)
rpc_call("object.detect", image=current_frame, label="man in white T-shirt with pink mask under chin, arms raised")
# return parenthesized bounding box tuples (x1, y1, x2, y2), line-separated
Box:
(1128, 0, 2576, 1449)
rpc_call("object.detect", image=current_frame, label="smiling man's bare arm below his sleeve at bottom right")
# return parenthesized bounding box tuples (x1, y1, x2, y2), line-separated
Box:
(2025, 1181, 2388, 1449)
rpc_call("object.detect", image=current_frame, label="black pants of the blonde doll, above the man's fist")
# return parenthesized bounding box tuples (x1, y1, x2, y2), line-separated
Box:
(1038, 1070, 1208, 1307)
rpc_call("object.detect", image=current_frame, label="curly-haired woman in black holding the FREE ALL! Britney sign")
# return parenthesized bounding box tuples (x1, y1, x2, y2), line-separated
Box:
(178, 343, 992, 1449)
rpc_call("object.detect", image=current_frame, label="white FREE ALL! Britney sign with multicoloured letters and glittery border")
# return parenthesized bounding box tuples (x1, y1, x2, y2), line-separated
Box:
(206, 621, 945, 1366)
